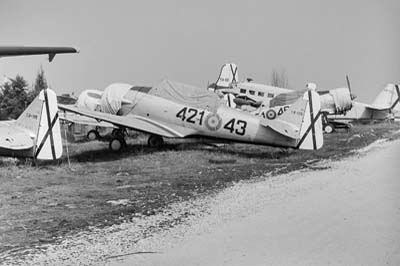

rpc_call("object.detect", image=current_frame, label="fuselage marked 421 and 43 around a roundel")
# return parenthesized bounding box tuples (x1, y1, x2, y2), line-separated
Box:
(121, 91, 297, 147)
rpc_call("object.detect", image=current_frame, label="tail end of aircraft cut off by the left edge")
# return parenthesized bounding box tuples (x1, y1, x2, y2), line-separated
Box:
(0, 89, 62, 160)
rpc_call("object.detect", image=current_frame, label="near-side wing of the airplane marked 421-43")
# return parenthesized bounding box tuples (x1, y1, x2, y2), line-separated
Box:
(58, 104, 191, 138)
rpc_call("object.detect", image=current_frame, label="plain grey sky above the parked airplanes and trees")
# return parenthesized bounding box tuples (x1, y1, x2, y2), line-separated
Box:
(0, 0, 400, 102)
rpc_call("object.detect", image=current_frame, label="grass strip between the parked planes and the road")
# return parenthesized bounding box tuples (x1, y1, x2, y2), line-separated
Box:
(0, 124, 400, 263)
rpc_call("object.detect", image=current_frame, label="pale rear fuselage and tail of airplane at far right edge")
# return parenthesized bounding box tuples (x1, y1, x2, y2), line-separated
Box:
(329, 84, 400, 122)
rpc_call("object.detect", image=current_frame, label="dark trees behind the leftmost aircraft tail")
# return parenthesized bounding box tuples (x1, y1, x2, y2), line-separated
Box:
(0, 67, 47, 120)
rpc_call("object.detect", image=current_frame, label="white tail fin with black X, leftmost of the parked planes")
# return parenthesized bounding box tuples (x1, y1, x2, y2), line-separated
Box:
(16, 89, 62, 160)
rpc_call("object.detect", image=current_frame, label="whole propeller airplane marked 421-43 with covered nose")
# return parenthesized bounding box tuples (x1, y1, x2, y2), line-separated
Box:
(59, 80, 323, 151)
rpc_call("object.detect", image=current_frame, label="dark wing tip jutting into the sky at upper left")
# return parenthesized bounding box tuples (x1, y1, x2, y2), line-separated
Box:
(0, 46, 79, 62)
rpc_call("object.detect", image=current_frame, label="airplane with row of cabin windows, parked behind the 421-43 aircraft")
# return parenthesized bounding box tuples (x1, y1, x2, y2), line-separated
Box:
(209, 63, 354, 134)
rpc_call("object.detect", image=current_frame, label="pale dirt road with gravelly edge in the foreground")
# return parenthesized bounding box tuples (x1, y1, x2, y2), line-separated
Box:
(109, 140, 400, 266)
